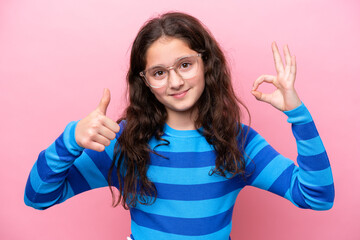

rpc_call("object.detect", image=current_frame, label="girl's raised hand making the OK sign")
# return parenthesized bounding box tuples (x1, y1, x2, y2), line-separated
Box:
(251, 42, 301, 111)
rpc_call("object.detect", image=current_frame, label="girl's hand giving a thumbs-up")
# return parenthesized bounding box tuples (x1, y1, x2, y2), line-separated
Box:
(75, 88, 120, 152)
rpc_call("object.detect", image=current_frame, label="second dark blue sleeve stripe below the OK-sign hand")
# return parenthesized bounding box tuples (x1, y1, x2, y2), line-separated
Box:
(297, 152, 330, 171)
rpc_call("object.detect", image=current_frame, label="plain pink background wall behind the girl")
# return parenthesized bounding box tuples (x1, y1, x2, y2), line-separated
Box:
(0, 0, 360, 240)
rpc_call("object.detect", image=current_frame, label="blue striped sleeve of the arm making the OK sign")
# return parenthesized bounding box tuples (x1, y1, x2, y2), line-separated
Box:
(245, 104, 334, 210)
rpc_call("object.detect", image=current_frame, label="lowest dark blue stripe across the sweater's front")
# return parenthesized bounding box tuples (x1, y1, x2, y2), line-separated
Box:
(130, 204, 233, 236)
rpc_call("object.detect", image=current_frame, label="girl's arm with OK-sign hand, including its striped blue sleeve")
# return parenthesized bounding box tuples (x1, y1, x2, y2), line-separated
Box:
(245, 42, 334, 210)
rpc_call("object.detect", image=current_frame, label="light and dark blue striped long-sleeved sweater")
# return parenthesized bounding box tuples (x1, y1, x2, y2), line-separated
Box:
(24, 104, 334, 240)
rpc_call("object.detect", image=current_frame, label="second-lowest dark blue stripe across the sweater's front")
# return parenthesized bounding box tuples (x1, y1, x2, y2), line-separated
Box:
(155, 175, 245, 201)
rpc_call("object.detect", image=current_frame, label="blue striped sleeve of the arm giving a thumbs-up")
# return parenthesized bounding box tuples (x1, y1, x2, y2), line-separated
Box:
(24, 122, 122, 210)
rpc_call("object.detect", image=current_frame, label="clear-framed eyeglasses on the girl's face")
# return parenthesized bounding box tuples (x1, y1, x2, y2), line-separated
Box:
(140, 53, 201, 88)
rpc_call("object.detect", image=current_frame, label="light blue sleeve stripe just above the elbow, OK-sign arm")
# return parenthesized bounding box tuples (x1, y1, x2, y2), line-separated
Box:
(299, 167, 333, 186)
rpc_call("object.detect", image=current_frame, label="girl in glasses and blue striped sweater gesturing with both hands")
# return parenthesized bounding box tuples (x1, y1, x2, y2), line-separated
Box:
(25, 12, 334, 240)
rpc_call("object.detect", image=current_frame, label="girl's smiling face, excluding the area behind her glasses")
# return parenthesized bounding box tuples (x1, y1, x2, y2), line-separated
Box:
(146, 37, 205, 117)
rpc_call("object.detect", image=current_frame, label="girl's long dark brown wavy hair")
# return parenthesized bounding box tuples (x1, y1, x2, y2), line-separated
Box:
(108, 12, 249, 209)
